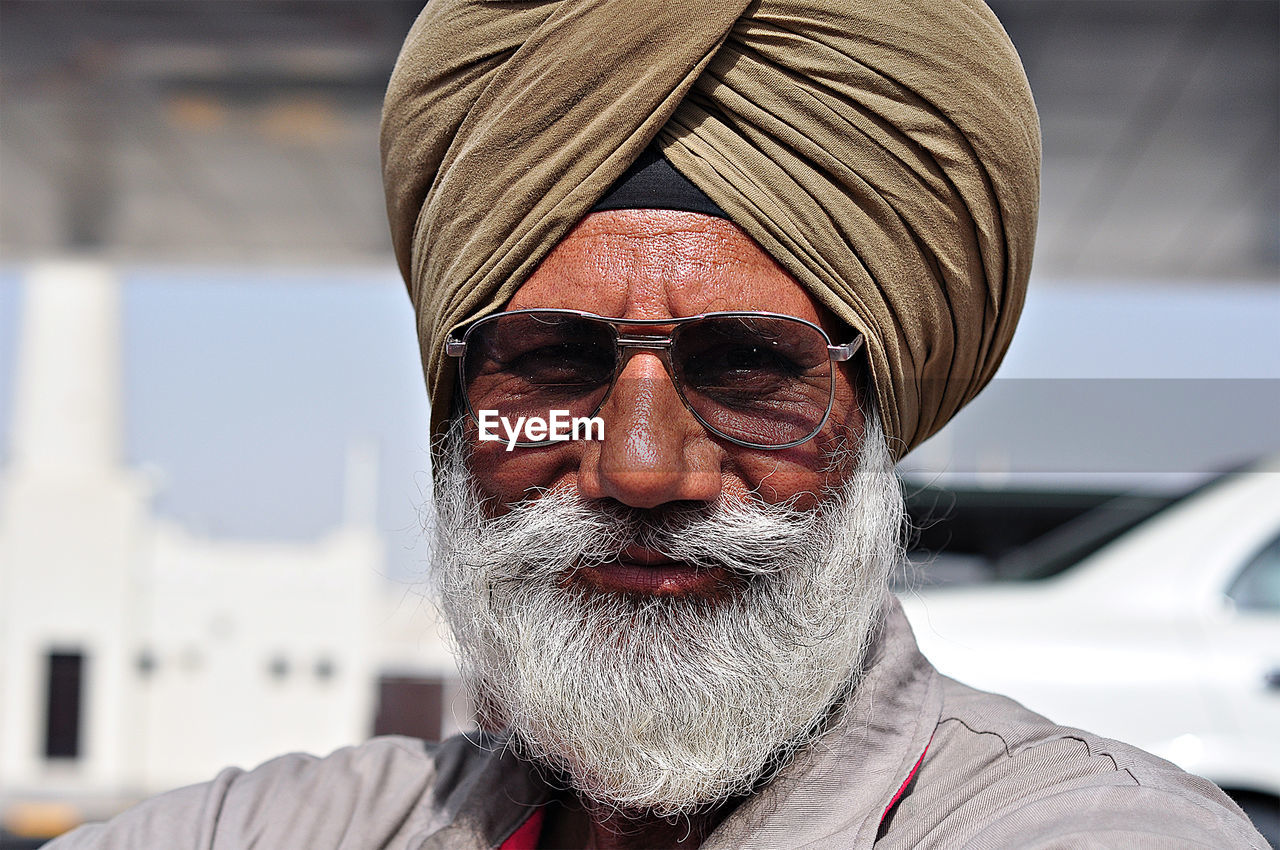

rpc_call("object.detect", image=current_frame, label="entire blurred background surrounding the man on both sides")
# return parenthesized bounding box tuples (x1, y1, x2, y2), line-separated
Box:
(0, 0, 1280, 847)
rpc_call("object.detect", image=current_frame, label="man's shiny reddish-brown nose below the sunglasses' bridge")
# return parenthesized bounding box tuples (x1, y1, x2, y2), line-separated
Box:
(579, 352, 721, 508)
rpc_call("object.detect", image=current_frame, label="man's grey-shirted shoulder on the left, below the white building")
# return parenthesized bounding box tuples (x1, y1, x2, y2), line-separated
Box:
(46, 736, 499, 850)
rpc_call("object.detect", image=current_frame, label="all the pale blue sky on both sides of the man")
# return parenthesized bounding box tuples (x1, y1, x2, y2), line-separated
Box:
(0, 266, 1280, 577)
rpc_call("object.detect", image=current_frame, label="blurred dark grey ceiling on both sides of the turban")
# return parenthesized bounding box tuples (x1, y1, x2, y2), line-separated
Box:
(0, 0, 1280, 283)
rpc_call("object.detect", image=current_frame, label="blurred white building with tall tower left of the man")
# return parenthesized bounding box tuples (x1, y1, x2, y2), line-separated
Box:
(0, 260, 453, 817)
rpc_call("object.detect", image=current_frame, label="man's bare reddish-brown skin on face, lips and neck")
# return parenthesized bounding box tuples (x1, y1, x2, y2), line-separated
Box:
(460, 210, 863, 850)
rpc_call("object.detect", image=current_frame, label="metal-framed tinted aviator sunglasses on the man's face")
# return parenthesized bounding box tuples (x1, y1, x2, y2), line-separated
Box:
(444, 309, 863, 449)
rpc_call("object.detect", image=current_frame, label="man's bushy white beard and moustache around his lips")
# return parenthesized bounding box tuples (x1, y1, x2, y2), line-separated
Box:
(433, 417, 902, 817)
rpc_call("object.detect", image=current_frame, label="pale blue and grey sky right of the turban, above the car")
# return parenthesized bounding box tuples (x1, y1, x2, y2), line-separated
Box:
(904, 279, 1280, 492)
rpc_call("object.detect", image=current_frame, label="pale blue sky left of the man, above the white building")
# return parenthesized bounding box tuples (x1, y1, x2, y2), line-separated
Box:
(0, 268, 430, 576)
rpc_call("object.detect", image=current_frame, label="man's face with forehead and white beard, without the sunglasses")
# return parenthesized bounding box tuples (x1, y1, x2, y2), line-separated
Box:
(435, 210, 901, 815)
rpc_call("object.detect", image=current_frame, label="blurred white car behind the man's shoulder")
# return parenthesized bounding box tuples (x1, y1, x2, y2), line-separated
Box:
(900, 460, 1280, 845)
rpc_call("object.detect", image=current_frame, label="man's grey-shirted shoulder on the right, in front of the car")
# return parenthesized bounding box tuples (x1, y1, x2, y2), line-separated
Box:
(895, 677, 1266, 849)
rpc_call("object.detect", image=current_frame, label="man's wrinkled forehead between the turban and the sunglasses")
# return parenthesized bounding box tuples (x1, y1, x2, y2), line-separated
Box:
(507, 210, 831, 330)
